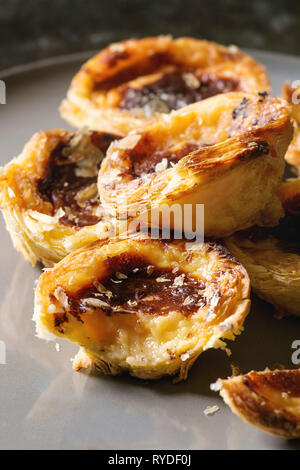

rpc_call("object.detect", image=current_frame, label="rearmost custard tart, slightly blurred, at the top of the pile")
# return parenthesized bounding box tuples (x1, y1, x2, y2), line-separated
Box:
(60, 36, 270, 135)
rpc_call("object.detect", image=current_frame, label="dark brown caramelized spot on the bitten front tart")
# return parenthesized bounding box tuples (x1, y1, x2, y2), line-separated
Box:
(61, 255, 206, 319)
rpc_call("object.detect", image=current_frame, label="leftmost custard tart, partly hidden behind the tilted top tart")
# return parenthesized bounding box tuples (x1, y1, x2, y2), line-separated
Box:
(0, 129, 119, 266)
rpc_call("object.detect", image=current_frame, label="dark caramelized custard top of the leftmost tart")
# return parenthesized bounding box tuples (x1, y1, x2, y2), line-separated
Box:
(38, 132, 117, 227)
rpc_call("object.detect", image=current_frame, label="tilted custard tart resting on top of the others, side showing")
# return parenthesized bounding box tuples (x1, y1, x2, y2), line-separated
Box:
(98, 92, 292, 238)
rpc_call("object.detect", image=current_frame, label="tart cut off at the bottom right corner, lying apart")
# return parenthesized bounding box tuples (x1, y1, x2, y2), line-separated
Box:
(217, 369, 300, 439)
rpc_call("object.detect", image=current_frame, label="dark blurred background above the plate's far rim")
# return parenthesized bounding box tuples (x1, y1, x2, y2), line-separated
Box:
(0, 0, 300, 69)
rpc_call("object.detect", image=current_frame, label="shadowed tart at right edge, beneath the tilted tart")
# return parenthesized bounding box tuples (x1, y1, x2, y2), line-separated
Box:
(225, 179, 300, 316)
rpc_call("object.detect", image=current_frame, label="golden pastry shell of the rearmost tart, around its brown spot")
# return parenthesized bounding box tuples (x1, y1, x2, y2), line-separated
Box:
(60, 36, 270, 135)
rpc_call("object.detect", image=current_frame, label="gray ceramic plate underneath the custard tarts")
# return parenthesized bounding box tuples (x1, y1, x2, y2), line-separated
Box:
(0, 52, 300, 450)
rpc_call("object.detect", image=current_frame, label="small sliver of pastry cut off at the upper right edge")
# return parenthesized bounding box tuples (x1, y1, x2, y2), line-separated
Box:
(282, 82, 300, 172)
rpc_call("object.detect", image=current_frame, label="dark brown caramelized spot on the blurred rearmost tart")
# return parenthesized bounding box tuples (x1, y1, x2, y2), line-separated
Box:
(120, 70, 238, 116)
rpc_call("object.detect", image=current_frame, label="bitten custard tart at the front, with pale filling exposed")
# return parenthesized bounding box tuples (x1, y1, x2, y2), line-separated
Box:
(34, 238, 250, 379)
